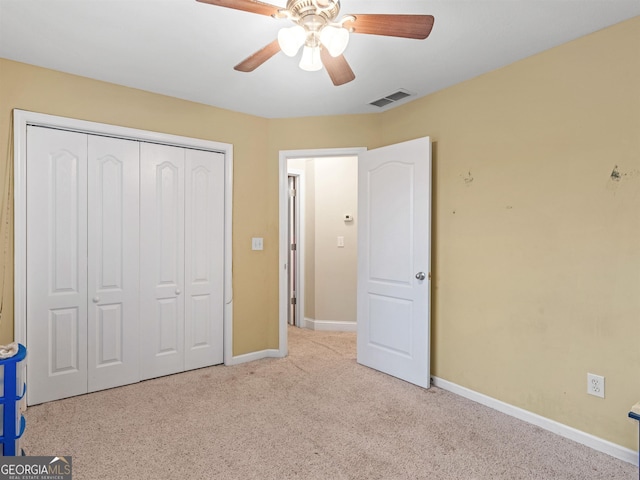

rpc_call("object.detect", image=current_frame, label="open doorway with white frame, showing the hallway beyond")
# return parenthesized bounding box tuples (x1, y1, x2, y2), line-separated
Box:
(279, 148, 365, 355)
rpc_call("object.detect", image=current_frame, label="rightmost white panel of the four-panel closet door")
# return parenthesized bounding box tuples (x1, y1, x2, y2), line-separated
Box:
(185, 150, 224, 370)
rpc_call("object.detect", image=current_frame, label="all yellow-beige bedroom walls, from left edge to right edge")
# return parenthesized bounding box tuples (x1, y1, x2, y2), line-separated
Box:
(0, 18, 640, 448)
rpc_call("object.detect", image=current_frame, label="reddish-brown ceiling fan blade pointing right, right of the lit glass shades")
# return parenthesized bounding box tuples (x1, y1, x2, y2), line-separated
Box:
(344, 13, 434, 40)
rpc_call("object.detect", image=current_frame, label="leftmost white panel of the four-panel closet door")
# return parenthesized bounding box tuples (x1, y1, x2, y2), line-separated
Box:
(27, 127, 87, 405)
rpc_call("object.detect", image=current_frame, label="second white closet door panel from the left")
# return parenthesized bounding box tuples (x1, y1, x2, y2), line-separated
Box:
(87, 136, 140, 392)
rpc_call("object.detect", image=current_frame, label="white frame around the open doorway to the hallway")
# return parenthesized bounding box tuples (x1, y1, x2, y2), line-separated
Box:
(278, 147, 367, 357)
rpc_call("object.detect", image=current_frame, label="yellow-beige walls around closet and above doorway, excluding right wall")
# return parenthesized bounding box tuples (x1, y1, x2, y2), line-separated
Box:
(0, 59, 378, 355)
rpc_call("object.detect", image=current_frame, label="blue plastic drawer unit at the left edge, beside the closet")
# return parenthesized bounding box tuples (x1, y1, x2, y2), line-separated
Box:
(0, 345, 27, 457)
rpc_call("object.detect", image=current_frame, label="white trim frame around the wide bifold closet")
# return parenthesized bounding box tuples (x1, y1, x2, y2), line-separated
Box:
(13, 109, 233, 365)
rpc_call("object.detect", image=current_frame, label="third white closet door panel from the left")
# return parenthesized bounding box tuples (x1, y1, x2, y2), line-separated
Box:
(140, 143, 185, 380)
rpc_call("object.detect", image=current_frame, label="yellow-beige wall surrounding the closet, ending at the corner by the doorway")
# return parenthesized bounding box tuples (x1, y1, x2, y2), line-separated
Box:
(0, 59, 278, 355)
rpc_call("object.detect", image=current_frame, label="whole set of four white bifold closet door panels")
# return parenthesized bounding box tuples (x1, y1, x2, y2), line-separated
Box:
(26, 126, 225, 405)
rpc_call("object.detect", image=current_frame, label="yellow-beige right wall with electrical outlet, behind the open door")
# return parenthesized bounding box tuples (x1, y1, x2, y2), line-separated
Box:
(381, 17, 640, 449)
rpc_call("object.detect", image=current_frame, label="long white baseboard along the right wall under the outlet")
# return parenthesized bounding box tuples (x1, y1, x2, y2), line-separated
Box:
(431, 377, 638, 465)
